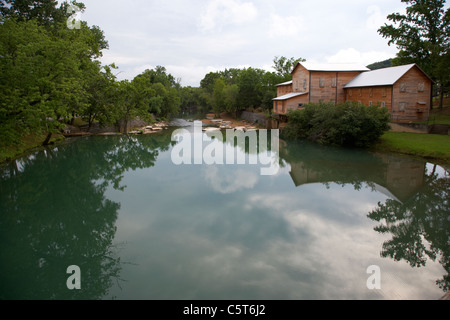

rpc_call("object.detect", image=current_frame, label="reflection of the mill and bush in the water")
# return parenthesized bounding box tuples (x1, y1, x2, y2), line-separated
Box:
(281, 143, 425, 201)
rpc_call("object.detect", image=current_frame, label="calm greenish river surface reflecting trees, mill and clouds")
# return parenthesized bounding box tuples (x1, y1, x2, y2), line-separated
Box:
(0, 125, 450, 300)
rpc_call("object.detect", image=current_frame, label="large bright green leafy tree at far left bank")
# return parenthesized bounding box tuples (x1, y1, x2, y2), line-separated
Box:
(0, 18, 106, 144)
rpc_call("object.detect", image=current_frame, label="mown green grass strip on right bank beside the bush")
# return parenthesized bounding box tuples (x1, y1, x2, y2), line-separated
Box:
(374, 132, 450, 165)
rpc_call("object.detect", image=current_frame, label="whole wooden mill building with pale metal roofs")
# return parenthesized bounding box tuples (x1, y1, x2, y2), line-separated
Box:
(273, 62, 433, 122)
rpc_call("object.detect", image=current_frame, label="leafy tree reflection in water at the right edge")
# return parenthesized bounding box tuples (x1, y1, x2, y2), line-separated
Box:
(368, 166, 450, 292)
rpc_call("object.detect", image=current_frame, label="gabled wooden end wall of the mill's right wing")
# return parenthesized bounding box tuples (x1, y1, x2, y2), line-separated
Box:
(392, 67, 432, 122)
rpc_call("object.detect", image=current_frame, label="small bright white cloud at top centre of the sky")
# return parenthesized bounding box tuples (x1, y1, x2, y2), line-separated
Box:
(200, 0, 258, 31)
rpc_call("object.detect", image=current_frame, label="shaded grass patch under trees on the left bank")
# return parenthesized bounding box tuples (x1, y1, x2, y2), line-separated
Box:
(0, 133, 64, 164)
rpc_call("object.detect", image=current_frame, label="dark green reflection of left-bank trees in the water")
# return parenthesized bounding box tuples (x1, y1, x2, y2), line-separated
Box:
(0, 136, 174, 299)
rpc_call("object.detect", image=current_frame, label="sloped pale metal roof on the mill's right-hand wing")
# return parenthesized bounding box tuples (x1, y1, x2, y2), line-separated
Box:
(344, 63, 416, 88)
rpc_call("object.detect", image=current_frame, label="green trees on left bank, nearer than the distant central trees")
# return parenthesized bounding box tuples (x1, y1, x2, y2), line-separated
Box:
(0, 0, 185, 147)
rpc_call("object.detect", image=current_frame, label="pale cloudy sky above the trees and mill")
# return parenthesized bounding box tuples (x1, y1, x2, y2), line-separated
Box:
(76, 0, 422, 86)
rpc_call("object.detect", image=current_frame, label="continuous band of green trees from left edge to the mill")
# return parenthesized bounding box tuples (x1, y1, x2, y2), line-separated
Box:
(0, 0, 300, 148)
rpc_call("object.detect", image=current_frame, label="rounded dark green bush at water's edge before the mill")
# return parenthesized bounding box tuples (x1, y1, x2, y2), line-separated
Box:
(283, 102, 390, 147)
